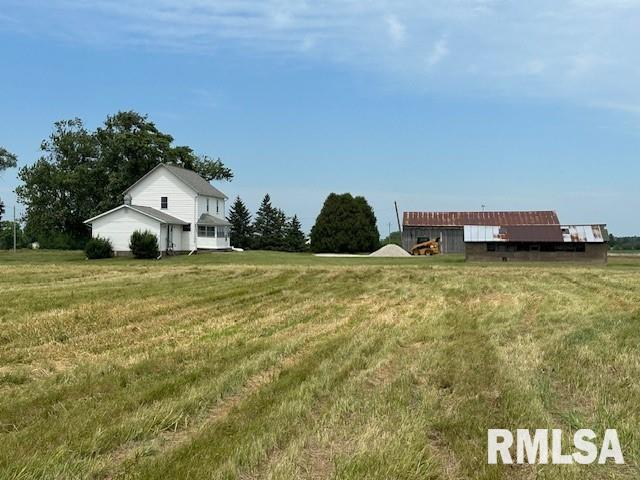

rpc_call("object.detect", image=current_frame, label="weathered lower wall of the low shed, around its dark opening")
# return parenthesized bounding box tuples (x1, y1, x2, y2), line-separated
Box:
(465, 242, 609, 264)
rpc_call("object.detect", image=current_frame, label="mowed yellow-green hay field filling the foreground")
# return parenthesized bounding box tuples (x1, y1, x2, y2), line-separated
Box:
(0, 252, 640, 479)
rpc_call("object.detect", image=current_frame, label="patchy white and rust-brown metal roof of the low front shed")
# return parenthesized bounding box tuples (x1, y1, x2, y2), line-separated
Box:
(464, 225, 609, 243)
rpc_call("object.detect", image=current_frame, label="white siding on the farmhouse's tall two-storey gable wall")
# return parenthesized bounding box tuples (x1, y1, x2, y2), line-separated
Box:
(128, 167, 197, 250)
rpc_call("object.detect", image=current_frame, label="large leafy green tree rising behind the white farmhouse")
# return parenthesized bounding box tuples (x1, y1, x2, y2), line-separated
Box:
(16, 112, 233, 247)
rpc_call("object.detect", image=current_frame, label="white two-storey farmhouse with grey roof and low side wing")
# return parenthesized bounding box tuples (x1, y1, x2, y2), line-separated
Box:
(84, 163, 231, 254)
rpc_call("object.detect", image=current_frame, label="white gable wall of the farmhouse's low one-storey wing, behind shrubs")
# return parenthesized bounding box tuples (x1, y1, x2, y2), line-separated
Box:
(91, 208, 161, 252)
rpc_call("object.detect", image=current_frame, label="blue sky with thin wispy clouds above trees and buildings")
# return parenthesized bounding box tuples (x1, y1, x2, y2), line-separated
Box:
(0, 0, 640, 236)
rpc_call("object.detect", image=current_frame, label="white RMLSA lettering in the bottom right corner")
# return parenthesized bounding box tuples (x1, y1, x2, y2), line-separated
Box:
(488, 428, 624, 465)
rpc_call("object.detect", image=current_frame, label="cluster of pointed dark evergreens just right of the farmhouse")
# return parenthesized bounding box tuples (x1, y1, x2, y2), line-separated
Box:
(227, 194, 307, 252)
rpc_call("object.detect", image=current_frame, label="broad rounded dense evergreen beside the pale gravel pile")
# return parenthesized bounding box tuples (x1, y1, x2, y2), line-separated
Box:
(311, 193, 380, 253)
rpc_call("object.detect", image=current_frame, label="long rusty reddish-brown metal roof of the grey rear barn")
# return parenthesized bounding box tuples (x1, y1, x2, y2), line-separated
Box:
(402, 210, 560, 227)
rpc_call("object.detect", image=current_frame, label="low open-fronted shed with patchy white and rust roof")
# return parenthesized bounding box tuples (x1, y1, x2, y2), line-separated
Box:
(464, 225, 609, 263)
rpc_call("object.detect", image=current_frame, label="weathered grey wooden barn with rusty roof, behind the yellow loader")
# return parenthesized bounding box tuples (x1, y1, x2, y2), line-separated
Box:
(402, 210, 560, 253)
